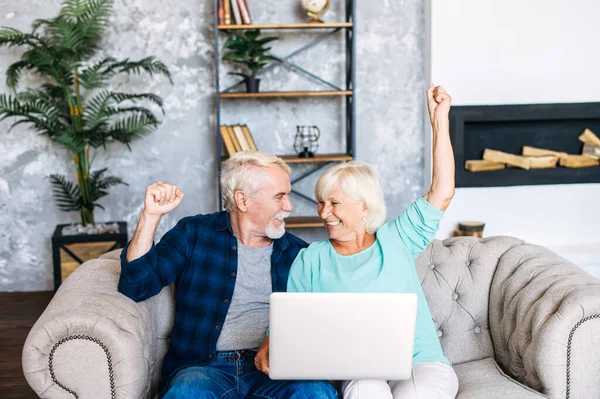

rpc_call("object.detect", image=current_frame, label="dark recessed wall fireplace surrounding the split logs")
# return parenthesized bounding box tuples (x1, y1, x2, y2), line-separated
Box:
(450, 103, 600, 187)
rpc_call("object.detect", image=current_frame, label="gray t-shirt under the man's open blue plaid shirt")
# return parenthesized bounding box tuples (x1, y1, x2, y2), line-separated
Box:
(217, 242, 273, 351)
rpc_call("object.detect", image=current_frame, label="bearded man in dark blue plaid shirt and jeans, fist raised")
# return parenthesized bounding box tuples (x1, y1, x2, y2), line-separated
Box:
(119, 152, 336, 398)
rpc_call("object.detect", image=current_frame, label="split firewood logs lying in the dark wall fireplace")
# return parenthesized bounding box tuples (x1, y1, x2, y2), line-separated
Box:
(465, 129, 600, 172)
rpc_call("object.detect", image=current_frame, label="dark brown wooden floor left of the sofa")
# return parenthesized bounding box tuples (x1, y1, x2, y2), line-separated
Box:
(0, 291, 54, 399)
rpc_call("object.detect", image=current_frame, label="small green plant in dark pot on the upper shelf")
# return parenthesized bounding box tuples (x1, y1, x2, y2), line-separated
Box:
(223, 29, 280, 93)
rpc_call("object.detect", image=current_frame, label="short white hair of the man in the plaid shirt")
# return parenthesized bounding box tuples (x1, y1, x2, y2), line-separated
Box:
(221, 151, 292, 212)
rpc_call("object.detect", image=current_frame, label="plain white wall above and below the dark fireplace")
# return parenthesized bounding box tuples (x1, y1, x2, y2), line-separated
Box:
(430, 0, 600, 253)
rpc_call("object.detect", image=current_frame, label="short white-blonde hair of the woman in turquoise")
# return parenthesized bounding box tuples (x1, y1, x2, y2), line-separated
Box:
(315, 161, 386, 234)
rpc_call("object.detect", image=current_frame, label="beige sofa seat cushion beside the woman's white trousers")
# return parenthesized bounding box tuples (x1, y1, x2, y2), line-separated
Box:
(454, 357, 545, 399)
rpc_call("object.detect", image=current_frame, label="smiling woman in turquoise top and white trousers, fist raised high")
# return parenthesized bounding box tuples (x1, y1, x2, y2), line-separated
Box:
(256, 85, 458, 399)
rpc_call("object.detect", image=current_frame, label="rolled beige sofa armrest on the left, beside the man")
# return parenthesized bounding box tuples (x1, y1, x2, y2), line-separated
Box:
(22, 250, 174, 398)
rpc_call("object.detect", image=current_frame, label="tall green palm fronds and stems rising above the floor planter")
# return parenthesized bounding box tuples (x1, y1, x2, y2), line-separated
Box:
(0, 0, 172, 288)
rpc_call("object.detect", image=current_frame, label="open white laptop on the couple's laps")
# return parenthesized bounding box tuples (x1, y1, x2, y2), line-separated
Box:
(269, 293, 417, 380)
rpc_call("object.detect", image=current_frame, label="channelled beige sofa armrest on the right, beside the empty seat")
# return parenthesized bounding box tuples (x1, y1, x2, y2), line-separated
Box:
(489, 244, 600, 398)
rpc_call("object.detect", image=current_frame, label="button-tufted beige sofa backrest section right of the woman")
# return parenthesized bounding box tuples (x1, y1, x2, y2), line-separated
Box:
(415, 237, 523, 364)
